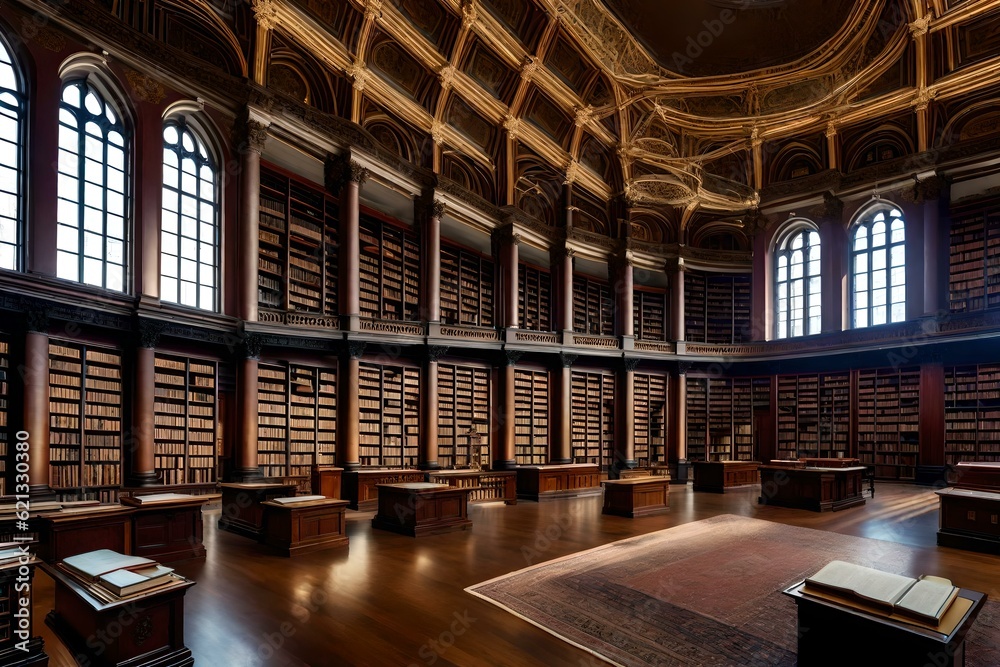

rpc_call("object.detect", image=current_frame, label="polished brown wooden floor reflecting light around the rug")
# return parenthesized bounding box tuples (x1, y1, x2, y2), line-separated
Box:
(34, 483, 1000, 667)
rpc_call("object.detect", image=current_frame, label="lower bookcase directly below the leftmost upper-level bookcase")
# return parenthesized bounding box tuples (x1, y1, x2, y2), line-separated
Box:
(257, 363, 337, 492)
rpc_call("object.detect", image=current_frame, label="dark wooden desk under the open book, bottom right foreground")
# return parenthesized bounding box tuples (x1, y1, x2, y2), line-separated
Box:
(783, 582, 986, 667)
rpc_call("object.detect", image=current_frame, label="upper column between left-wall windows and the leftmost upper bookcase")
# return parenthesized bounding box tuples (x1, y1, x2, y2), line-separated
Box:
(237, 109, 269, 322)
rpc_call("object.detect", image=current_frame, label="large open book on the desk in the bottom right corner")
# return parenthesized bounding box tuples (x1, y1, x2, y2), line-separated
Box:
(803, 560, 958, 624)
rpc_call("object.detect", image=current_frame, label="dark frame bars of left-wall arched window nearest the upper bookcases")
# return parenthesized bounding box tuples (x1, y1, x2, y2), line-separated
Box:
(157, 114, 222, 313)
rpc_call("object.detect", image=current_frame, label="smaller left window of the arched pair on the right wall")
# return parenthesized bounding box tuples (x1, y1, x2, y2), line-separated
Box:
(774, 228, 822, 338)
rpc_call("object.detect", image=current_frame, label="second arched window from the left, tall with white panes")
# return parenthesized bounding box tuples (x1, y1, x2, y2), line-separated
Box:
(56, 79, 129, 292)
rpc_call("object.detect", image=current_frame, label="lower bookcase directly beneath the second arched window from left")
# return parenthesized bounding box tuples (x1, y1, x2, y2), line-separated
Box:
(49, 340, 122, 502)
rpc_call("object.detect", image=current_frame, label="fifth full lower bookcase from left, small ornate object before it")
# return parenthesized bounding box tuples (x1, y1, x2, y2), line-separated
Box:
(438, 364, 491, 468)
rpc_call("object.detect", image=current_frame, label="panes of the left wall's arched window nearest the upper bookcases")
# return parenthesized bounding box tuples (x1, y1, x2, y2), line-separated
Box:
(160, 118, 219, 310)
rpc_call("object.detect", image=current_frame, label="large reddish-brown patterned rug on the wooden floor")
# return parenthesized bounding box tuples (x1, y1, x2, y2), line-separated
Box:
(466, 515, 1000, 667)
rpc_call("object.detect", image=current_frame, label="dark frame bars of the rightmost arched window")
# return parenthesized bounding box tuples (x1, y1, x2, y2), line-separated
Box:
(847, 201, 907, 329)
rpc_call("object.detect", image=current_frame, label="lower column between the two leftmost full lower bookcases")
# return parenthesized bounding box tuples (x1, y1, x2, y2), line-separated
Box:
(126, 320, 163, 487)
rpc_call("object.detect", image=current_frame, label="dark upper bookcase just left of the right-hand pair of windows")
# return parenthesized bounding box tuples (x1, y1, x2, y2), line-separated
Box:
(684, 270, 753, 345)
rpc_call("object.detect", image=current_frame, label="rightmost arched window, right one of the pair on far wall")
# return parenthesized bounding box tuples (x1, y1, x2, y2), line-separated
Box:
(851, 205, 906, 329)
